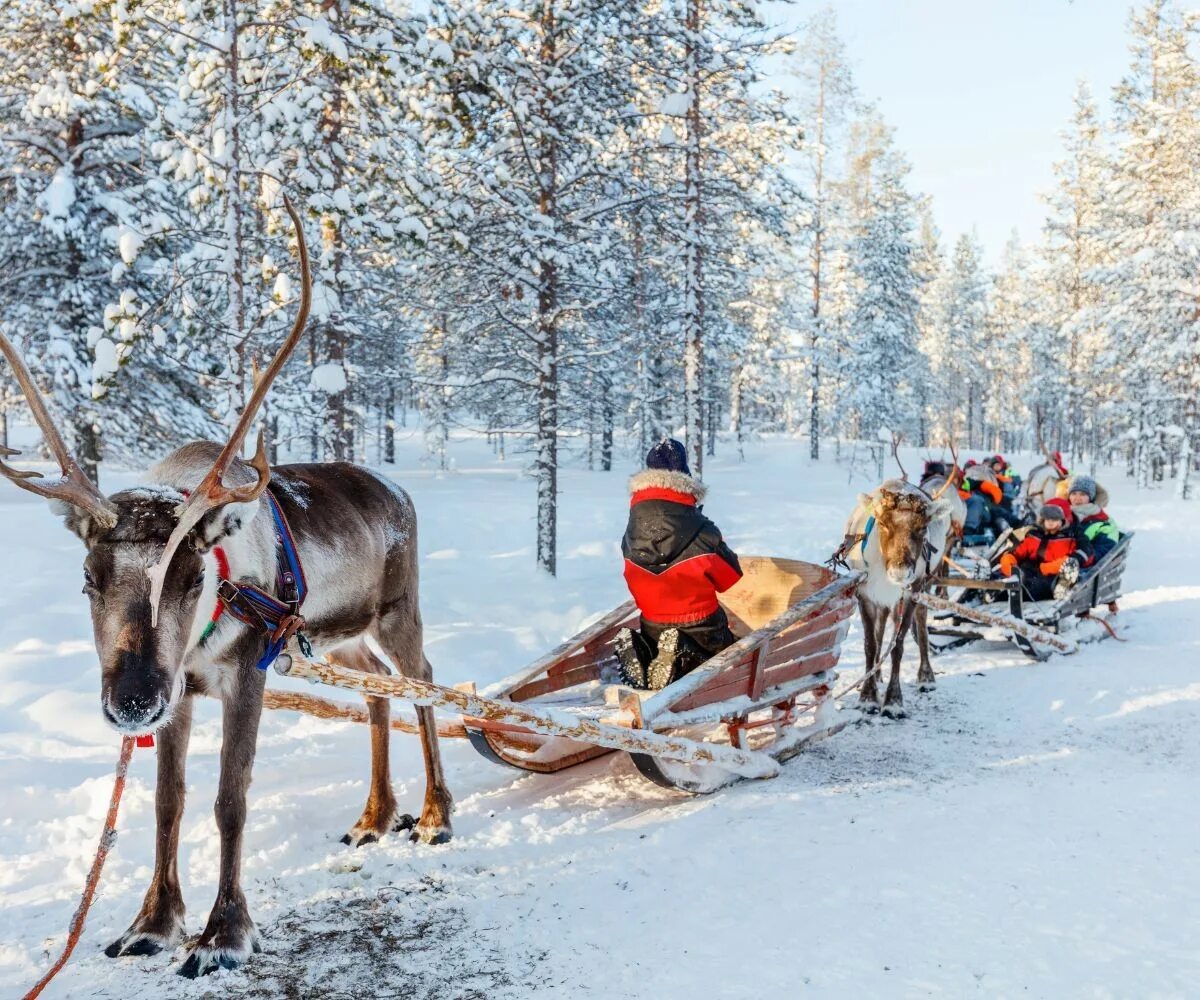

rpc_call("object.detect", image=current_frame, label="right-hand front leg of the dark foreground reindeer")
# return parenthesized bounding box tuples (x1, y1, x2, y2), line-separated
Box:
(179, 663, 265, 978)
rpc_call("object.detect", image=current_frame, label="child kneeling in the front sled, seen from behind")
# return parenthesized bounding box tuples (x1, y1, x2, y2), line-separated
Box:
(616, 438, 742, 690)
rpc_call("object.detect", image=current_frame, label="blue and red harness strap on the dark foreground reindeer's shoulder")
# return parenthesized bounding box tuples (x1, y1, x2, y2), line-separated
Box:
(217, 490, 312, 670)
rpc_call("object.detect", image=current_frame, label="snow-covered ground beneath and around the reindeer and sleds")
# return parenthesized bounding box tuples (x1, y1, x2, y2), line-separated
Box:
(0, 438, 1200, 1000)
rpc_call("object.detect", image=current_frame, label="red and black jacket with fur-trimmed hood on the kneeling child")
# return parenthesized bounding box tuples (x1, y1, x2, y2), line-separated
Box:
(620, 471, 742, 625)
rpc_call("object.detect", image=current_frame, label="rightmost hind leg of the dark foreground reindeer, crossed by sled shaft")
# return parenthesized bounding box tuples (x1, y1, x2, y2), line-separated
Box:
(376, 600, 454, 844)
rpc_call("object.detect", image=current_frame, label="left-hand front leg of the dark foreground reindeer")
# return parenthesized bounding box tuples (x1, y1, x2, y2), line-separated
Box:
(104, 694, 192, 958)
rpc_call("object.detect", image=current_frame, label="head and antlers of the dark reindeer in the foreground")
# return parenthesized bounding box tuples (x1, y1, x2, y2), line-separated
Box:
(0, 198, 312, 732)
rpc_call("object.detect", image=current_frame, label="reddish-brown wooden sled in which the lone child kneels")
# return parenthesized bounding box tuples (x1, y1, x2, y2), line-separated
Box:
(453, 556, 858, 792)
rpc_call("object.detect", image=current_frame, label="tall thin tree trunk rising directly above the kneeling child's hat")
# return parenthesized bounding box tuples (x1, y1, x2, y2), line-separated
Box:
(683, 0, 704, 478)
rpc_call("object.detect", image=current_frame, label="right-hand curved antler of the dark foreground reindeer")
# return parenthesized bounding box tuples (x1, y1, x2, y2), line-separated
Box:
(146, 194, 312, 627)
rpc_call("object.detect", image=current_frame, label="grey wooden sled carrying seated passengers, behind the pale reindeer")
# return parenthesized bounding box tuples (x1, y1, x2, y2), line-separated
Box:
(928, 532, 1133, 660)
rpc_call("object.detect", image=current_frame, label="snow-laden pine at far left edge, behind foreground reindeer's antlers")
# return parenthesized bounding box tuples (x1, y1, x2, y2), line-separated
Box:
(0, 4, 209, 478)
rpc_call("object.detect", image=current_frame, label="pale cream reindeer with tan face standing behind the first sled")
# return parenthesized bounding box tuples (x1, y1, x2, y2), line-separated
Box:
(835, 479, 952, 719)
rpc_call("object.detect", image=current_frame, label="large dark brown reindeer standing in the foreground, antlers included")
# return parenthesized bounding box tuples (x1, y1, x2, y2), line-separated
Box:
(0, 199, 452, 977)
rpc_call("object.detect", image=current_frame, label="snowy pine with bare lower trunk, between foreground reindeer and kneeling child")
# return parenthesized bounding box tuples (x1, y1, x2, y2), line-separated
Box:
(424, 0, 648, 573)
